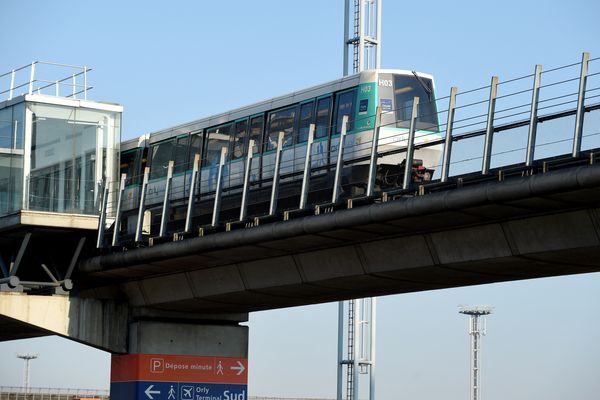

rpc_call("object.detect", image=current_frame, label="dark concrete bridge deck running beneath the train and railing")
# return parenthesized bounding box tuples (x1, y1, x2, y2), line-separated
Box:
(79, 160, 600, 313)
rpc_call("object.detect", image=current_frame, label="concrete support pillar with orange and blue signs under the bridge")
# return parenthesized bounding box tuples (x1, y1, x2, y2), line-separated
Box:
(110, 321, 248, 400)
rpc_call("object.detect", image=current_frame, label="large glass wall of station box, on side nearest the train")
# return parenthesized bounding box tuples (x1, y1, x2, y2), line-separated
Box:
(28, 103, 120, 214)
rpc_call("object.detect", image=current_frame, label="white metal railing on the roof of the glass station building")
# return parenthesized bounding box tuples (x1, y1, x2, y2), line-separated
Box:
(0, 61, 92, 100)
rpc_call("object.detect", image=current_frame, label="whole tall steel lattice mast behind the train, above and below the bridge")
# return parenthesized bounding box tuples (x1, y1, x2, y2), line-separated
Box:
(337, 0, 381, 400)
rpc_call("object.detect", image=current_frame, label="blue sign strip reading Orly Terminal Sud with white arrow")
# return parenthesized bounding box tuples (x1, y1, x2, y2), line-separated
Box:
(110, 381, 248, 400)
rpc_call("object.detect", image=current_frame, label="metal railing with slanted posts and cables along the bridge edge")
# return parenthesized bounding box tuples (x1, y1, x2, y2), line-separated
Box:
(98, 53, 600, 247)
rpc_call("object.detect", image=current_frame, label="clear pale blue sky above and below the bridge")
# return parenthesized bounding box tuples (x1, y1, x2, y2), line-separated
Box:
(0, 0, 600, 400)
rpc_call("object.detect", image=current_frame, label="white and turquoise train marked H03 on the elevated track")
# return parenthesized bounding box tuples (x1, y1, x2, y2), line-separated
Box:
(114, 69, 441, 236)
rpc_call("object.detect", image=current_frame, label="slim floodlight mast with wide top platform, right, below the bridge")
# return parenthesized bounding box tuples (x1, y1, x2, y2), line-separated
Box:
(459, 306, 492, 400)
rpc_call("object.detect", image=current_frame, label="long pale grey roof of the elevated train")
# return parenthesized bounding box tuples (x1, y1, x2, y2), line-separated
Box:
(121, 69, 433, 151)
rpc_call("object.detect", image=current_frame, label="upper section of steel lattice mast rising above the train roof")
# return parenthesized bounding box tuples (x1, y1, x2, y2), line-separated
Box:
(344, 0, 381, 76)
